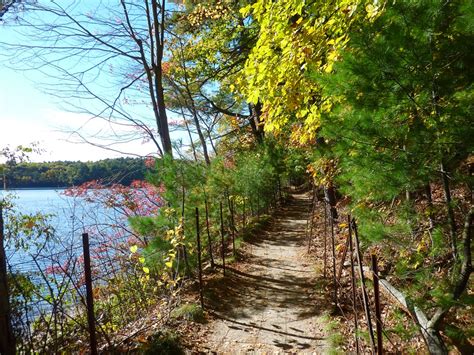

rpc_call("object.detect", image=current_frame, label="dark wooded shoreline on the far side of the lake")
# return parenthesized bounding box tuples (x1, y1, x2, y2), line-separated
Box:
(0, 158, 146, 188)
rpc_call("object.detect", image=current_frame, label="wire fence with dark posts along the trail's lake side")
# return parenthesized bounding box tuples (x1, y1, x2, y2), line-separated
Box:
(0, 184, 282, 353)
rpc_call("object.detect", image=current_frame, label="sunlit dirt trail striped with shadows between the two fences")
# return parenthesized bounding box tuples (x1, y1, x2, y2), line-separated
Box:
(204, 194, 327, 354)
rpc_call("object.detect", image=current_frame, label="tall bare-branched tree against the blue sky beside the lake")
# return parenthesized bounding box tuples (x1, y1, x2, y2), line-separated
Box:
(2, 0, 172, 154)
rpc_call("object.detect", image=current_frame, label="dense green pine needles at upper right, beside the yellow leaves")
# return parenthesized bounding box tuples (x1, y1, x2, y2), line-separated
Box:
(314, 2, 474, 206)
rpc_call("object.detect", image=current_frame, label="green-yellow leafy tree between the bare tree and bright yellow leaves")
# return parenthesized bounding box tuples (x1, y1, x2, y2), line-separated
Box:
(173, 0, 264, 143)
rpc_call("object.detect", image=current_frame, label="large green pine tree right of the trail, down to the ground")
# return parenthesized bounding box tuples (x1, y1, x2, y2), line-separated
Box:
(312, 1, 474, 353)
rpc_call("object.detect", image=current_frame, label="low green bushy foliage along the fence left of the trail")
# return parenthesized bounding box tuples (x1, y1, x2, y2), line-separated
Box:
(130, 142, 287, 290)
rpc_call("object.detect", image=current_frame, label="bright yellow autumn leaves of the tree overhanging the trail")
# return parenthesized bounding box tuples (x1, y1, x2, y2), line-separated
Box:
(239, 0, 379, 143)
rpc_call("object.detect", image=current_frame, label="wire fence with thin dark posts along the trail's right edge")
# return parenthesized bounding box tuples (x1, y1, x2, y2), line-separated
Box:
(307, 188, 420, 354)
